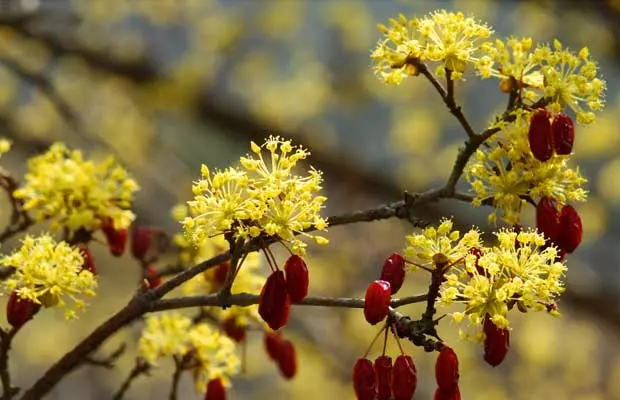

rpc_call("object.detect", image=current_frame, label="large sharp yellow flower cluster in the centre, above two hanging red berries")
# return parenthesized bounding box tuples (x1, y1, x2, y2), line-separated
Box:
(183, 136, 327, 255)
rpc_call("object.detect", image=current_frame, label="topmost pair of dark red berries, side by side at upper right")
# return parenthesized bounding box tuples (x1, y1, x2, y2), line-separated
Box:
(528, 108, 575, 162)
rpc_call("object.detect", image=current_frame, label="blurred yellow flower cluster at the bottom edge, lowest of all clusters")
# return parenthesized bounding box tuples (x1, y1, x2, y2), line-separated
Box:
(138, 312, 241, 392)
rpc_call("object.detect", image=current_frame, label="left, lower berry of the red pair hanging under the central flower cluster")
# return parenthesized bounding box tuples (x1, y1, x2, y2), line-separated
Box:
(258, 271, 291, 331)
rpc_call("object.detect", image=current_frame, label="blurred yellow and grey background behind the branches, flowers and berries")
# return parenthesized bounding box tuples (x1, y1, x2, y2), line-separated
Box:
(0, 0, 620, 400)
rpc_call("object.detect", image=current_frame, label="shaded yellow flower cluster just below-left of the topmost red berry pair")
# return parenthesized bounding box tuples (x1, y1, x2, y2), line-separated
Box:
(465, 110, 587, 224)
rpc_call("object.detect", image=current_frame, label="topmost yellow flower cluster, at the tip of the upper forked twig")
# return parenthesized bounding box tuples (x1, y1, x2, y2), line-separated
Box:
(371, 10, 493, 85)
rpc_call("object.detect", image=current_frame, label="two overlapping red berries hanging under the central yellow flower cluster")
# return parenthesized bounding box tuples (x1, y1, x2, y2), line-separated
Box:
(258, 255, 309, 331)
